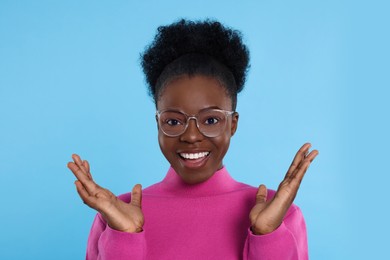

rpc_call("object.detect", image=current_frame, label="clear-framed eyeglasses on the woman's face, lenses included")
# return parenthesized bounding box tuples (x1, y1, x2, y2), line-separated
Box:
(156, 109, 235, 137)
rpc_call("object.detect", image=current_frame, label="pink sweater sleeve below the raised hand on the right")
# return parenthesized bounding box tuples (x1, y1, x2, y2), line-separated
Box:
(244, 205, 308, 260)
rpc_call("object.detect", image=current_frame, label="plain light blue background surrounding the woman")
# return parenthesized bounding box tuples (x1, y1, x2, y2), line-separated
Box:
(0, 0, 390, 259)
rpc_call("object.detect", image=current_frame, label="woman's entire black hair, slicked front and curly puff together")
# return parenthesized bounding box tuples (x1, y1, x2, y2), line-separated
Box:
(141, 19, 249, 110)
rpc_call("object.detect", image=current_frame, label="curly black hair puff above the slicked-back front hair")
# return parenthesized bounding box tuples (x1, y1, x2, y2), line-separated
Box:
(141, 19, 249, 96)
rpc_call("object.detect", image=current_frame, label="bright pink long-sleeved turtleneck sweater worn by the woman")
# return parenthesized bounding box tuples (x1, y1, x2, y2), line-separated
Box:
(87, 168, 308, 260)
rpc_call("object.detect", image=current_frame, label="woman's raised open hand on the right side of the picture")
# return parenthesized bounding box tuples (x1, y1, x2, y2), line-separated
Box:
(249, 143, 318, 235)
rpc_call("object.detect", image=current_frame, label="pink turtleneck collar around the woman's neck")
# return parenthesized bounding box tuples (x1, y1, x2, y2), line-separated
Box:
(162, 167, 240, 197)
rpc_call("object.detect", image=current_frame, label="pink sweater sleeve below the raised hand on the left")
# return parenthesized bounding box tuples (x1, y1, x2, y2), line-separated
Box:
(86, 214, 146, 260)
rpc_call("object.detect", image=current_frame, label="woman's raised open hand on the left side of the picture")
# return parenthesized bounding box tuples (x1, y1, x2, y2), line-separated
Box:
(68, 154, 144, 233)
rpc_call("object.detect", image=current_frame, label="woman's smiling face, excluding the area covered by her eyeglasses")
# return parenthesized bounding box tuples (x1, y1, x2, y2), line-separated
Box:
(157, 75, 238, 184)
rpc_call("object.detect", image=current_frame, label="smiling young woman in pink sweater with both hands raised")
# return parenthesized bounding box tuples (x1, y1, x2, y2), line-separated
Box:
(68, 20, 318, 260)
